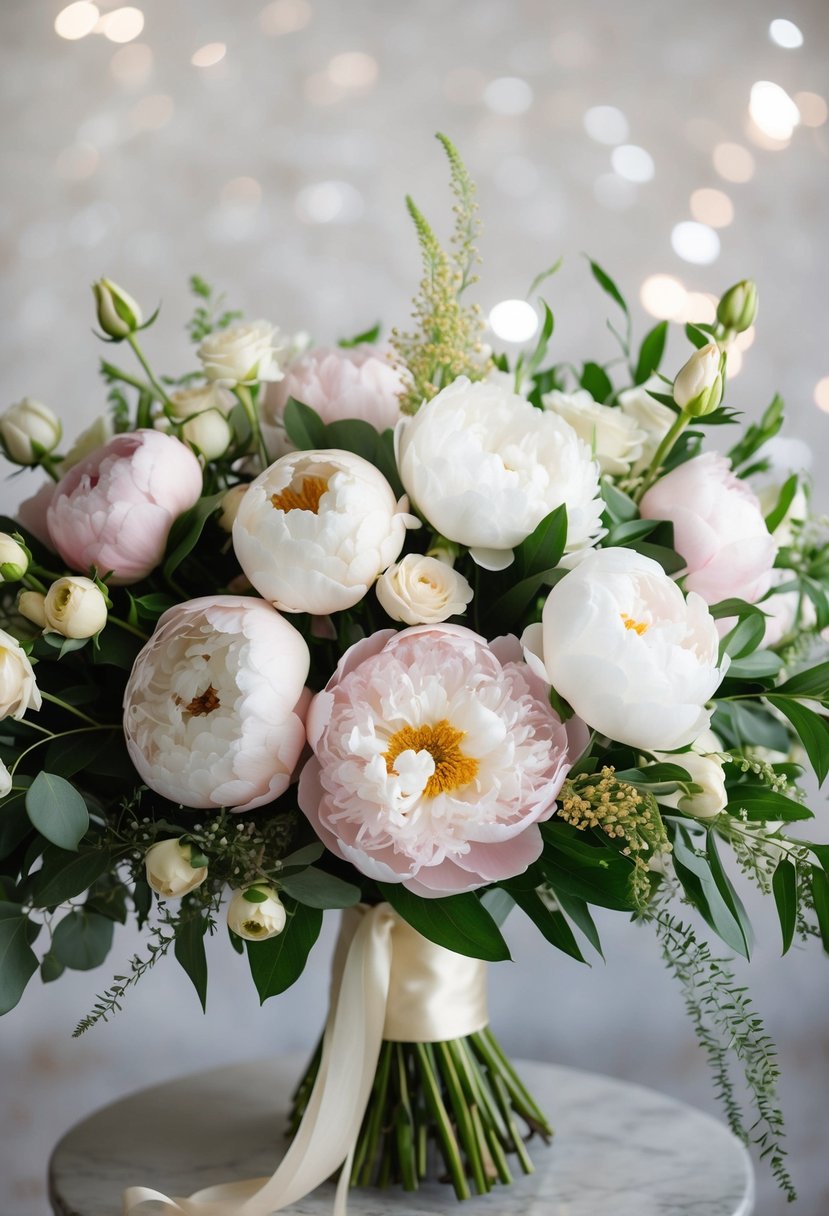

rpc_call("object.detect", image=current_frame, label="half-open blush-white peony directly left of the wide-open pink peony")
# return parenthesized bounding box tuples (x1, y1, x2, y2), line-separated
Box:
(124, 596, 310, 811)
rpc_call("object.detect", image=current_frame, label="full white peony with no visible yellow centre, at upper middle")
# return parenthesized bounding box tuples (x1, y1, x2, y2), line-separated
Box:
(395, 376, 603, 570)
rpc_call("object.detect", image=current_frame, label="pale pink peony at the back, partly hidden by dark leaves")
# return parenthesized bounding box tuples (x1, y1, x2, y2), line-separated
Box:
(264, 347, 406, 457)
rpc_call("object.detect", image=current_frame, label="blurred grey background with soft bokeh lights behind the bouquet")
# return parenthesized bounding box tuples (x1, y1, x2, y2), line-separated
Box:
(0, 0, 829, 1216)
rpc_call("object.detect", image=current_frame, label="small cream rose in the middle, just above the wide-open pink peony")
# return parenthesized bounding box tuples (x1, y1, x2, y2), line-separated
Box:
(376, 553, 473, 625)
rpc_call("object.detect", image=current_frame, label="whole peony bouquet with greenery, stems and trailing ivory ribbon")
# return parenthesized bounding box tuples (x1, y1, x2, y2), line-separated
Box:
(0, 136, 829, 1216)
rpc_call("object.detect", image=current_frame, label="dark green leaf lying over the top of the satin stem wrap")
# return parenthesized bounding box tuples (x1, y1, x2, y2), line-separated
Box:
(377, 883, 511, 963)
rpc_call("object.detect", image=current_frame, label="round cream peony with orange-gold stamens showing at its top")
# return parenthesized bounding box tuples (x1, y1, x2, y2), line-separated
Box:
(233, 450, 419, 617)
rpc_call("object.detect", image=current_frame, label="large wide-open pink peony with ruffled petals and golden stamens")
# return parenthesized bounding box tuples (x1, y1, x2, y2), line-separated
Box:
(299, 625, 570, 897)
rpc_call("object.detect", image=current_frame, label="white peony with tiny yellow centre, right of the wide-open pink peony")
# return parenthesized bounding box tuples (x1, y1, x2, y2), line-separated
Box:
(523, 548, 727, 751)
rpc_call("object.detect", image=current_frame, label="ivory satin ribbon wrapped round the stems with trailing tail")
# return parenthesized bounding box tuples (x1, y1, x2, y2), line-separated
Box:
(124, 903, 489, 1216)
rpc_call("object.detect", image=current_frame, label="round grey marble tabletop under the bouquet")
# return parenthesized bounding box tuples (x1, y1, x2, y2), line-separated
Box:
(50, 1057, 754, 1216)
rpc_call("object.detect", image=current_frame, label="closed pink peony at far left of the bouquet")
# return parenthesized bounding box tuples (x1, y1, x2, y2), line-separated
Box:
(46, 430, 202, 584)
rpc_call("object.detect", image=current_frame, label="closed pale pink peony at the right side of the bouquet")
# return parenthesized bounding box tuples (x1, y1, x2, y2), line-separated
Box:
(639, 452, 777, 604)
